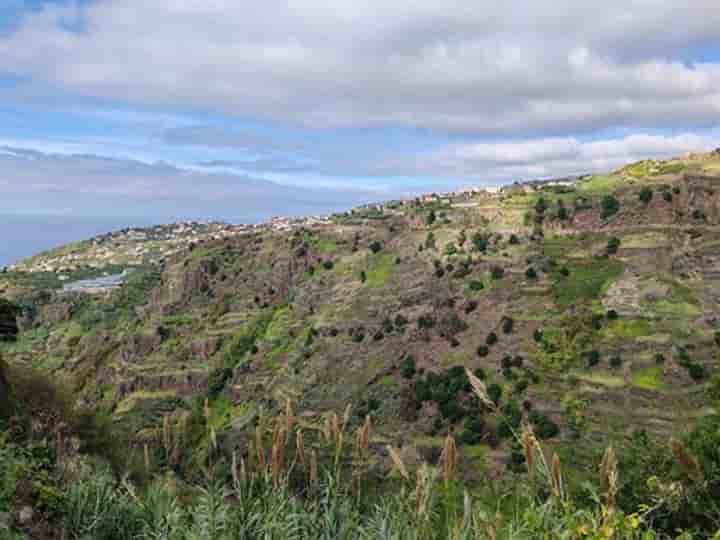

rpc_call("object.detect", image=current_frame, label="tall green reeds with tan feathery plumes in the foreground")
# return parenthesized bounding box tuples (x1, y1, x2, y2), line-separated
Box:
(54, 382, 680, 540)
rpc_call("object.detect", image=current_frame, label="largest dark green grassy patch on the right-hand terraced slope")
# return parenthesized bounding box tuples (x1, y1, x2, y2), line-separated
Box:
(553, 259, 623, 306)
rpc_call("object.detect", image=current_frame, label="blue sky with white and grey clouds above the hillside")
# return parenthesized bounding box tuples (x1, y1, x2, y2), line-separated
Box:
(0, 0, 720, 221)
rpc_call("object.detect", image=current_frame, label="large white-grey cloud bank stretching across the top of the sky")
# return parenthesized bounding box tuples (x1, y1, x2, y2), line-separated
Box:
(0, 0, 720, 135)
